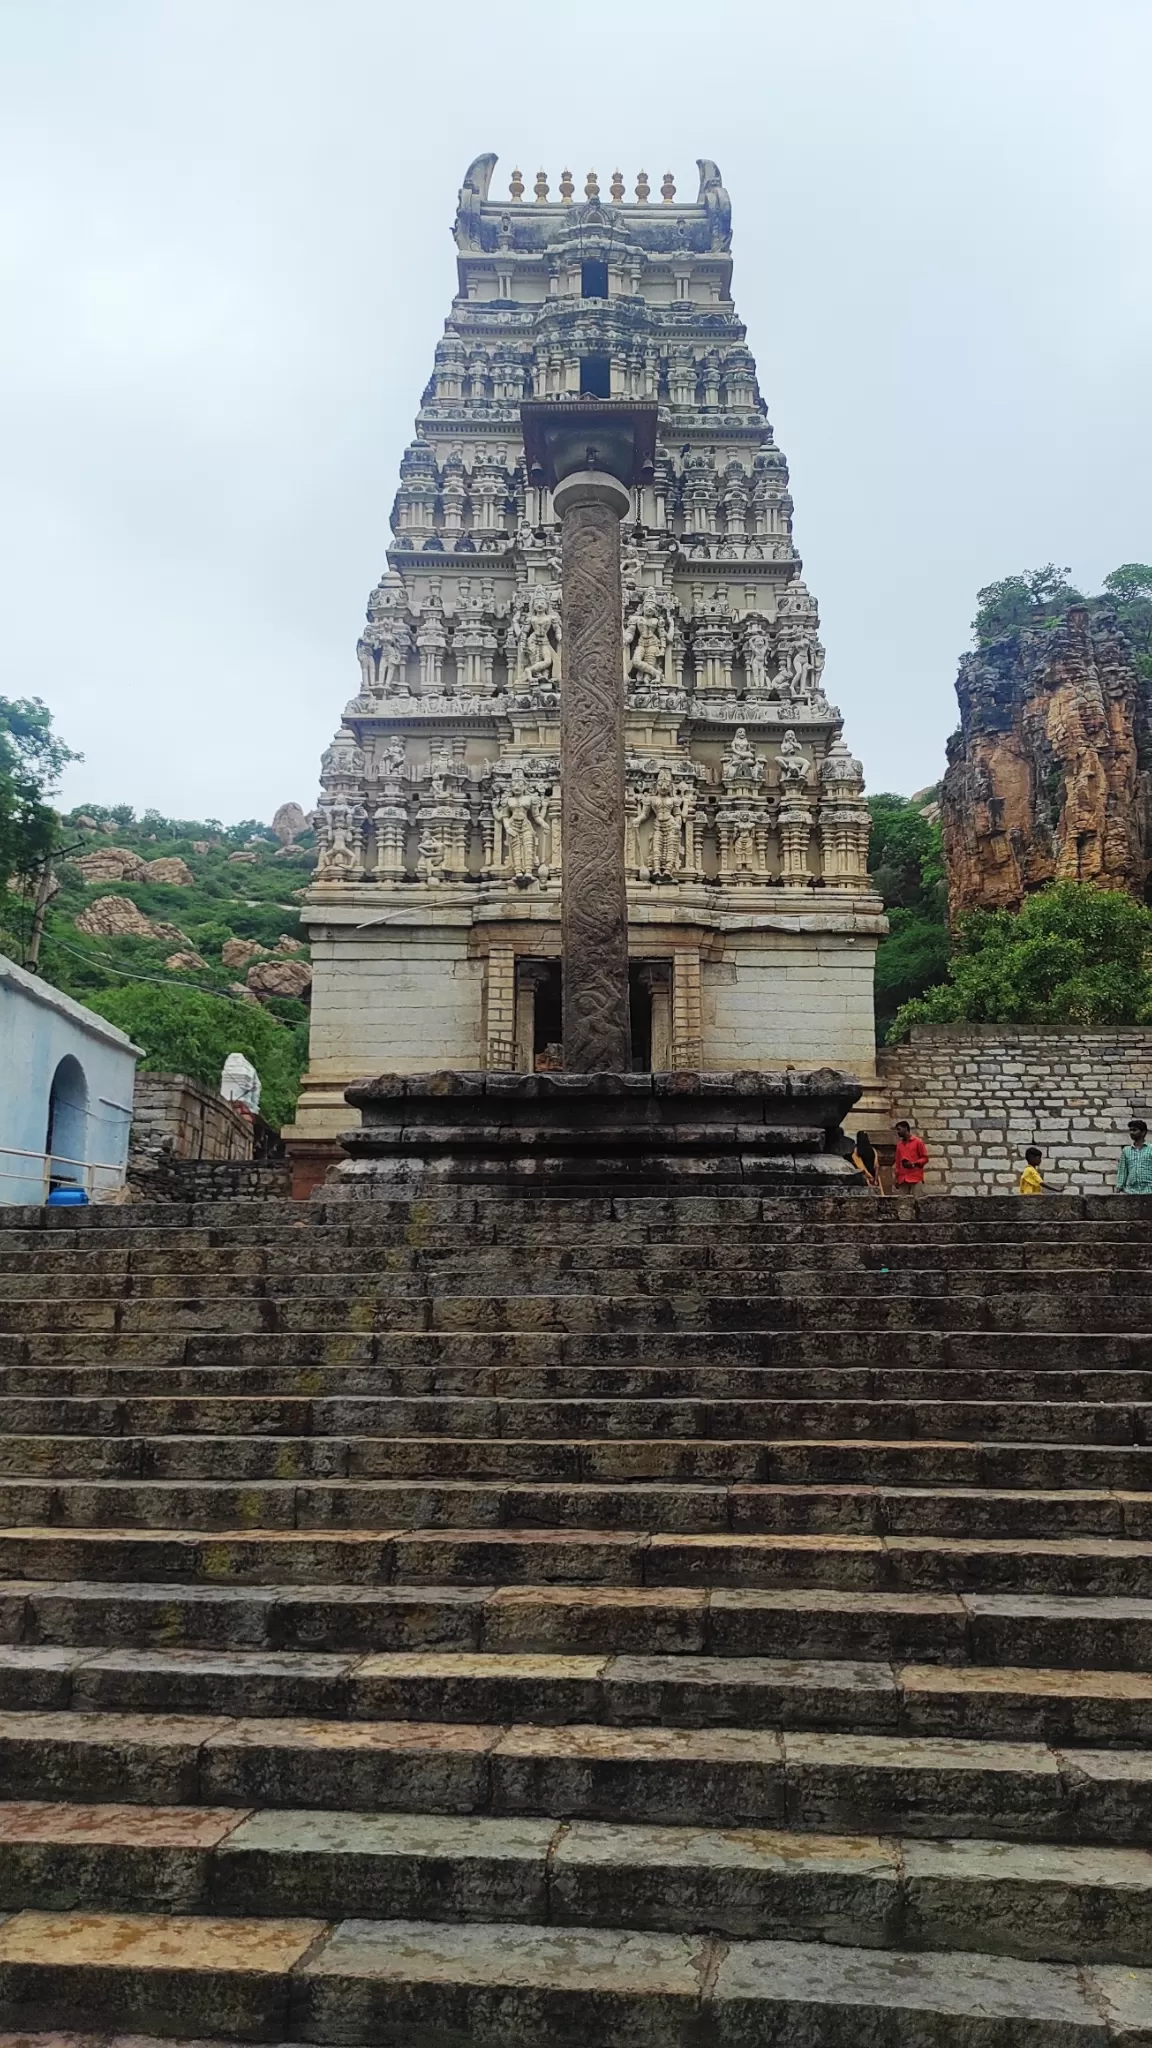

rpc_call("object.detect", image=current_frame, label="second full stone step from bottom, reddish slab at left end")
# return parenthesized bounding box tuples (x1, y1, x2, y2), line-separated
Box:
(0, 1800, 1152, 1964)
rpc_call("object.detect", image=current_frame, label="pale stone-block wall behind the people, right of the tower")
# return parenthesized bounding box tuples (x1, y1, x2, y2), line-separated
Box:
(877, 1024, 1152, 1194)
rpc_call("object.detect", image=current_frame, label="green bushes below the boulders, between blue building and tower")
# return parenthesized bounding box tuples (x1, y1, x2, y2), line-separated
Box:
(84, 983, 307, 1126)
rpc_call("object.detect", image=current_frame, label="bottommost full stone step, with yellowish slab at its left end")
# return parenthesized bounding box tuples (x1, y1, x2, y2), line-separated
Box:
(0, 1913, 1152, 2048)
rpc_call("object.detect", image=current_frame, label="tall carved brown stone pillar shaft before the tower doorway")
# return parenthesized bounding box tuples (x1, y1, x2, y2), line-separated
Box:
(553, 469, 631, 1073)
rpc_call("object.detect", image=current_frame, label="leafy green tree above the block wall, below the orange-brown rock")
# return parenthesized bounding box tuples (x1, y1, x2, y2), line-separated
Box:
(890, 883, 1152, 1040)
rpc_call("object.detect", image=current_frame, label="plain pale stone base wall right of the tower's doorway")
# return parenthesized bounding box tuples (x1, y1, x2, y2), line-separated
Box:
(701, 930, 875, 1077)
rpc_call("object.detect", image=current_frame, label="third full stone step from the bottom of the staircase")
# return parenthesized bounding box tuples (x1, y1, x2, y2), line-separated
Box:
(0, 1708, 1152, 1847)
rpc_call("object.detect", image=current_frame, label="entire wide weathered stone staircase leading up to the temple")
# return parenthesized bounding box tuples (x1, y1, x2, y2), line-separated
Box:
(0, 1194, 1152, 2048)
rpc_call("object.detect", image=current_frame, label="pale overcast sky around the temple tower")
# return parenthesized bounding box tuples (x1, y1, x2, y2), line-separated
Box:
(0, 0, 1152, 819)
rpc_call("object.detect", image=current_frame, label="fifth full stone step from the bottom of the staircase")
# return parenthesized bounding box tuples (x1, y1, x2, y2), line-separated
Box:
(13, 1579, 1152, 1673)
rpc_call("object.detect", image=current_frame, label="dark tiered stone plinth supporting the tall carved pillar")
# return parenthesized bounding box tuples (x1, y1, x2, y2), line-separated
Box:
(318, 1067, 863, 1202)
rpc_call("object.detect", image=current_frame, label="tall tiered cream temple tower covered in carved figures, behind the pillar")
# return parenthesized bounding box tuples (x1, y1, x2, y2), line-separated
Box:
(287, 156, 883, 1169)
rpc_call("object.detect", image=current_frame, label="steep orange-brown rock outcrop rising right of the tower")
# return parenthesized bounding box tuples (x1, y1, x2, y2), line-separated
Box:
(941, 606, 1152, 920)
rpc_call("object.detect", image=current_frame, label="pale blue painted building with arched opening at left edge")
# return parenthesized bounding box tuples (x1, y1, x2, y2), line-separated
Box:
(0, 954, 141, 1202)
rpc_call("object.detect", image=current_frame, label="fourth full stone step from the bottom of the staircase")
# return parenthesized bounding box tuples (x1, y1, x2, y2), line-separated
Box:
(0, 1645, 1152, 1747)
